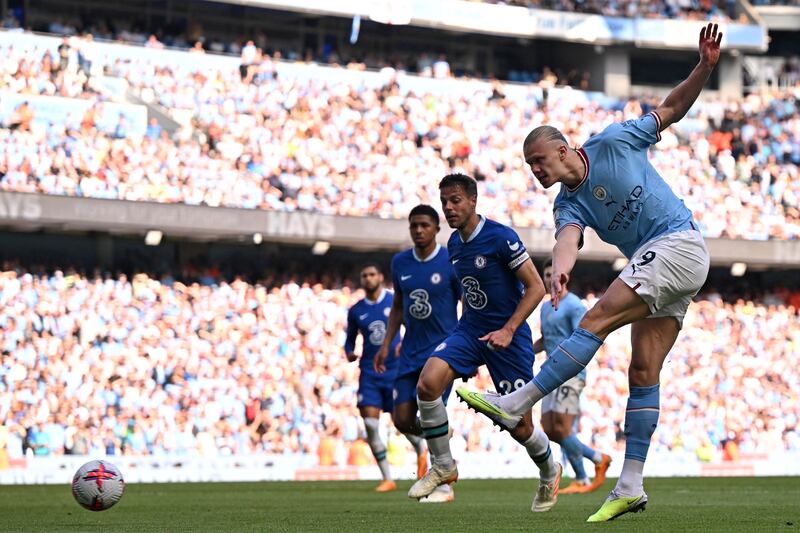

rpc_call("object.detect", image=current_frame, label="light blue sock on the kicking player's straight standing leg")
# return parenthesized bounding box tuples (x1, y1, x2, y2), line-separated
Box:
(616, 384, 659, 496)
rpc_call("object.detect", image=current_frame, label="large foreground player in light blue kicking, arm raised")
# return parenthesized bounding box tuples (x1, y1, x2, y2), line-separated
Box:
(459, 24, 722, 522)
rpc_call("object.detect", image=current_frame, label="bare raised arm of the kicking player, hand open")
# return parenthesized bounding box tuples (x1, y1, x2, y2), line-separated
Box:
(656, 23, 722, 131)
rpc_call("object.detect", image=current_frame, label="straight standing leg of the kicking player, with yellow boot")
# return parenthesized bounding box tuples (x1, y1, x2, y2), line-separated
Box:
(588, 316, 680, 522)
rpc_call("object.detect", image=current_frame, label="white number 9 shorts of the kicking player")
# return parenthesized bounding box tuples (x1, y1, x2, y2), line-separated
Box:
(619, 230, 710, 326)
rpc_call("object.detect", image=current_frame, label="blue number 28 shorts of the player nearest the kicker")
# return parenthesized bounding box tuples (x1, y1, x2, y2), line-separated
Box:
(431, 329, 535, 394)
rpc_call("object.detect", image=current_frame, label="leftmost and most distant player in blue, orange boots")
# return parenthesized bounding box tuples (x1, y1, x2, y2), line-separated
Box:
(344, 263, 404, 492)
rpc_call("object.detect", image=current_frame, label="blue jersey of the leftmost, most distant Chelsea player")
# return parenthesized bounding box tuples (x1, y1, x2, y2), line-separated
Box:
(344, 289, 400, 380)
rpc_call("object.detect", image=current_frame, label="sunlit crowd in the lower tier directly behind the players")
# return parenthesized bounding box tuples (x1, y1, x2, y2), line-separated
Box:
(0, 264, 800, 465)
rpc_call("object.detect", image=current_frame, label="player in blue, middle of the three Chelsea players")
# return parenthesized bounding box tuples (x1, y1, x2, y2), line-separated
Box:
(373, 205, 461, 503)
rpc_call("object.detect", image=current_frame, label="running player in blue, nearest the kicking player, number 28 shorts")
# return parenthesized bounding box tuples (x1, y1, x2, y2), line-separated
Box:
(408, 174, 561, 512)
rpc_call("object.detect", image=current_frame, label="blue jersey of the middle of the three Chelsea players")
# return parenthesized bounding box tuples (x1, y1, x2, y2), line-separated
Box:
(392, 245, 461, 374)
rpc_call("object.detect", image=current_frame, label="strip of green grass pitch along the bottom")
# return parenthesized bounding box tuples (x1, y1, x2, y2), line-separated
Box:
(0, 478, 800, 533)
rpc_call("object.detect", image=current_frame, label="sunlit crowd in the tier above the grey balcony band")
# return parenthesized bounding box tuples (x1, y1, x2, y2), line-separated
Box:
(0, 41, 800, 239)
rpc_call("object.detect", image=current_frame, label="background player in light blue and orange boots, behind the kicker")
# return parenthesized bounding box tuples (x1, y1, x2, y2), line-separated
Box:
(533, 260, 611, 494)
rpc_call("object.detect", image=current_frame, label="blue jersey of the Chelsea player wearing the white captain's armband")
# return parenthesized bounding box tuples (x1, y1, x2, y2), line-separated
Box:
(447, 216, 530, 337)
